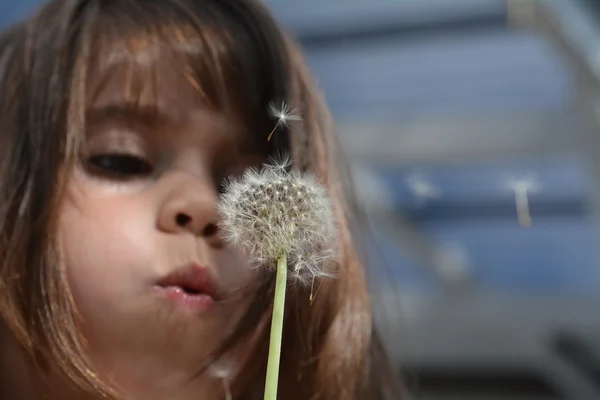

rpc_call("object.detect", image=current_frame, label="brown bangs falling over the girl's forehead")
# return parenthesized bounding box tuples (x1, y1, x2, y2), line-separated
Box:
(81, 0, 287, 141)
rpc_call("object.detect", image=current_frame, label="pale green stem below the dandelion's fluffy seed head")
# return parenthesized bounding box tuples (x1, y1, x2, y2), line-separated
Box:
(264, 253, 287, 400)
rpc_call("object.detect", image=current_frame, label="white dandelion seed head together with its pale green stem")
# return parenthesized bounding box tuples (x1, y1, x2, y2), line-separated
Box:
(220, 158, 337, 400)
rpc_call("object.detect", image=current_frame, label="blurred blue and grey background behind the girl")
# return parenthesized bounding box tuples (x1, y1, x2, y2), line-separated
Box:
(0, 0, 600, 400)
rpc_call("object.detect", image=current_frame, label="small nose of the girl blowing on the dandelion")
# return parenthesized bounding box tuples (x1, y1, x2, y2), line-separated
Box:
(157, 172, 222, 247)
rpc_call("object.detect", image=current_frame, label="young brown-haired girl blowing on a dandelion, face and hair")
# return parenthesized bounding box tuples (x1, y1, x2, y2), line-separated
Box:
(0, 0, 399, 400)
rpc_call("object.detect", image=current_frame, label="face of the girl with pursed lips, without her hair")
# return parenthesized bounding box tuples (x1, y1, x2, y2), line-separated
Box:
(60, 64, 266, 400)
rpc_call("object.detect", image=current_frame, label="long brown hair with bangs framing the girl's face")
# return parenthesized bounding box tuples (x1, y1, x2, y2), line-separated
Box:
(0, 0, 400, 400)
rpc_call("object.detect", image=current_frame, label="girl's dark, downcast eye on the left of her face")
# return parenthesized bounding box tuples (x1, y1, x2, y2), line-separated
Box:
(87, 154, 153, 179)
